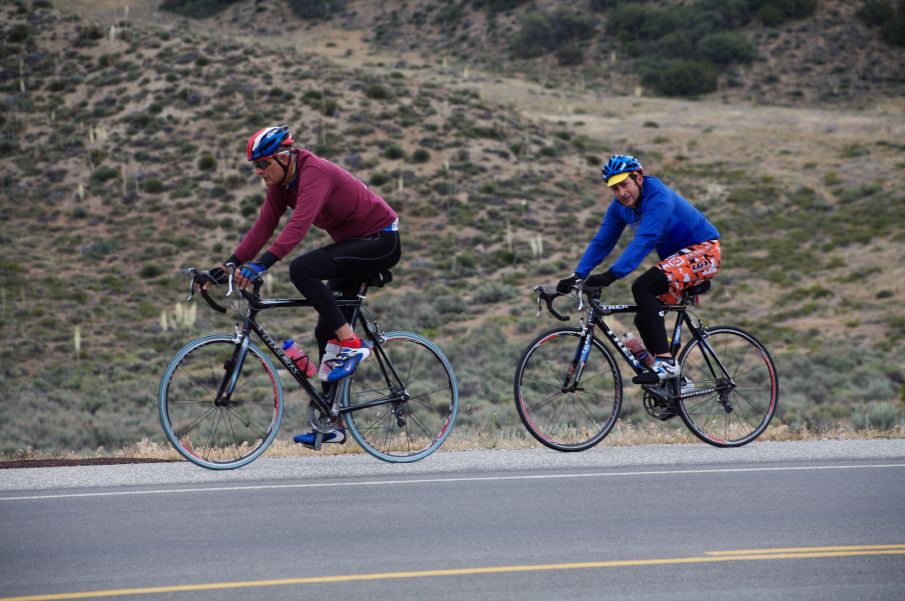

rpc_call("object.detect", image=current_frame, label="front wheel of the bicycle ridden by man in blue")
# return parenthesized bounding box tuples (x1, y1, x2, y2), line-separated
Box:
(514, 328, 623, 452)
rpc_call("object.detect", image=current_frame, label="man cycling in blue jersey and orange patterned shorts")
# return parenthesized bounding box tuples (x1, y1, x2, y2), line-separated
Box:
(556, 154, 721, 384)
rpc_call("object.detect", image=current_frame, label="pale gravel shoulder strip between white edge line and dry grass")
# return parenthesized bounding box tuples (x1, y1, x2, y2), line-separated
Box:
(0, 439, 905, 492)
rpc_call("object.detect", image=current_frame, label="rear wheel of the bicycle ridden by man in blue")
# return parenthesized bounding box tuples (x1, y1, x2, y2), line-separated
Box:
(678, 326, 779, 447)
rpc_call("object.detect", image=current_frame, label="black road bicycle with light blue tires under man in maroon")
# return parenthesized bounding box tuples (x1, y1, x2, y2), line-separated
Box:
(158, 268, 459, 470)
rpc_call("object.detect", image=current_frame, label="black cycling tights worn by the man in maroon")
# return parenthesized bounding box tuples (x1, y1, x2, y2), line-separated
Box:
(289, 232, 401, 357)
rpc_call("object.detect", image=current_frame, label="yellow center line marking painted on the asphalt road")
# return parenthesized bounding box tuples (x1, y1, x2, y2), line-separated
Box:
(0, 544, 905, 601)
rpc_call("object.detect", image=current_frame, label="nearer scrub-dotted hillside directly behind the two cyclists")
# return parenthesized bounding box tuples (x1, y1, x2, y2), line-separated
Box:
(0, 0, 905, 452)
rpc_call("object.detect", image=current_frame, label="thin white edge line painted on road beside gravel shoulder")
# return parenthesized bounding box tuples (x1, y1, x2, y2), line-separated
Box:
(0, 463, 905, 501)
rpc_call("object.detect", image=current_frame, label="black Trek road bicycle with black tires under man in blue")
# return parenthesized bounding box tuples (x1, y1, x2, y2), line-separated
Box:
(515, 281, 779, 451)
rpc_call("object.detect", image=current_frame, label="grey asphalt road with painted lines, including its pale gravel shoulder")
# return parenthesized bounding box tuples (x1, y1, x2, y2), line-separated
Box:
(0, 440, 905, 601)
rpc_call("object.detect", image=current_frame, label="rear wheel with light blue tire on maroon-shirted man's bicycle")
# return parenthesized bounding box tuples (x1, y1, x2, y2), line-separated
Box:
(339, 332, 459, 463)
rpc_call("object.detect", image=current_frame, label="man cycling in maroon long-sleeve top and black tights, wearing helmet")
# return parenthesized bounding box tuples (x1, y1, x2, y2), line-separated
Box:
(207, 125, 401, 446)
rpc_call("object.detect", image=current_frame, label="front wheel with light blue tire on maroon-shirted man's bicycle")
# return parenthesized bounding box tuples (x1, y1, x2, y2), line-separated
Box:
(157, 334, 283, 470)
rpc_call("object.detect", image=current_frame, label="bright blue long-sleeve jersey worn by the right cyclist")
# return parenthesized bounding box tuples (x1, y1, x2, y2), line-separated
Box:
(575, 175, 720, 278)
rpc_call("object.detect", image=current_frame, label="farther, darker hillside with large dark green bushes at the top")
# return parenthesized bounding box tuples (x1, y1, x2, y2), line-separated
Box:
(192, 0, 905, 107)
